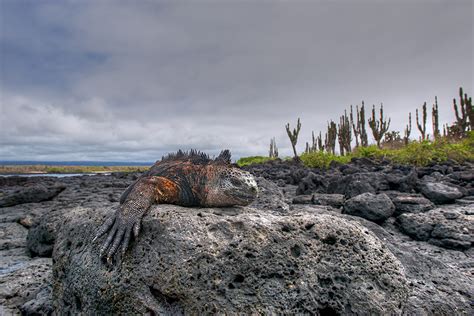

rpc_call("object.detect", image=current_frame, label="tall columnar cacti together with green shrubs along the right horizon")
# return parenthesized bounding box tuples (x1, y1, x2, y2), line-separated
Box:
(252, 88, 474, 168)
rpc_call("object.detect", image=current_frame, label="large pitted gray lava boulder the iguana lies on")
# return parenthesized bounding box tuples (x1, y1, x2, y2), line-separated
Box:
(53, 205, 408, 314)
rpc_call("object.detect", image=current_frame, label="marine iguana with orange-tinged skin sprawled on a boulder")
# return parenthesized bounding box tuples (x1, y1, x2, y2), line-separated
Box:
(94, 150, 258, 261)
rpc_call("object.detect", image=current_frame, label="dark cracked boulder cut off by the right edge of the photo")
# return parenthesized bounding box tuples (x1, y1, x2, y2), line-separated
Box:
(397, 206, 474, 250)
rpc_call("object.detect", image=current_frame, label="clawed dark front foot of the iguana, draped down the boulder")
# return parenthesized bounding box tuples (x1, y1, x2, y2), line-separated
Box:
(93, 207, 141, 263)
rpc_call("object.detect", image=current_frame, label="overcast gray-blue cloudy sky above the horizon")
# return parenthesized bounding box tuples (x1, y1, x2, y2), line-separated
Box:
(0, 0, 474, 161)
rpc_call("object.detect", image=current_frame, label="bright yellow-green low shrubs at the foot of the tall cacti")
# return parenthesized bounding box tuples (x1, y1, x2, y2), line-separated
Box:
(300, 131, 474, 168)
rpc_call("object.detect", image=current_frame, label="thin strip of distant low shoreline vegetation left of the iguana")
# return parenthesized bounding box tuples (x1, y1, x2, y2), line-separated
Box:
(0, 165, 150, 174)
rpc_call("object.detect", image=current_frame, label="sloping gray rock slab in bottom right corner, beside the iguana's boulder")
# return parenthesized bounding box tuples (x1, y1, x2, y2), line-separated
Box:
(335, 214, 474, 315)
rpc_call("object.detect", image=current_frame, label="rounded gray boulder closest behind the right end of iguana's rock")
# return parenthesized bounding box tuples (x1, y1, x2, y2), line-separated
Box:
(344, 193, 395, 223)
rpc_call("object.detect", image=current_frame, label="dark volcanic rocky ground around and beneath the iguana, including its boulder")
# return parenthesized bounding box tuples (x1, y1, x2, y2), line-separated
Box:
(0, 159, 474, 315)
